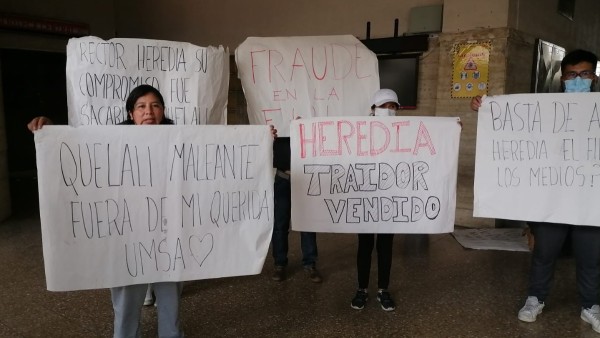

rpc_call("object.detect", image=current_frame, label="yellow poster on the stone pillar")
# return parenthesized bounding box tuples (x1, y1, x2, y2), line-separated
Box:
(452, 41, 492, 98)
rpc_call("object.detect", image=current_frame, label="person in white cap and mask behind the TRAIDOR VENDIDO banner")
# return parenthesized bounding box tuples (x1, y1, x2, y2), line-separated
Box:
(350, 89, 400, 311)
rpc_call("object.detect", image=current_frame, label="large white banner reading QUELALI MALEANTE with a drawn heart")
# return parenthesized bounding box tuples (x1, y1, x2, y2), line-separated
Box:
(35, 126, 273, 291)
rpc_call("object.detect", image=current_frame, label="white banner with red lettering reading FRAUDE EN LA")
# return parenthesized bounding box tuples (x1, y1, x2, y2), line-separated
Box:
(235, 35, 379, 136)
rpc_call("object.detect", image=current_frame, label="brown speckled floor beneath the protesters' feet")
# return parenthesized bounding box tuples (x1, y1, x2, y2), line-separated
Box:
(0, 213, 600, 337)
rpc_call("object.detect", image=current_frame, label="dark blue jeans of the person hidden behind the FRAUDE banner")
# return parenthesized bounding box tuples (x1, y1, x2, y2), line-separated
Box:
(271, 175, 318, 267)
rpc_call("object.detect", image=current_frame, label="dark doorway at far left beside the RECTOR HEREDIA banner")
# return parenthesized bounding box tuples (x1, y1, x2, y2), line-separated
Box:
(0, 49, 68, 215)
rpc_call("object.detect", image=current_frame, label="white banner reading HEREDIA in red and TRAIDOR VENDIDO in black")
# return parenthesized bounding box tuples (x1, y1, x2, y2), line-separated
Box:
(290, 116, 460, 233)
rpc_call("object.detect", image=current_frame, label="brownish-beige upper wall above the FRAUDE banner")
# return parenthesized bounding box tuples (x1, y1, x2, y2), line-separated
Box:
(117, 0, 444, 48)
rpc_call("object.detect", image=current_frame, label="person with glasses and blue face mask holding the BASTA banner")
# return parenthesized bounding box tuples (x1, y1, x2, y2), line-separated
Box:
(471, 49, 600, 333)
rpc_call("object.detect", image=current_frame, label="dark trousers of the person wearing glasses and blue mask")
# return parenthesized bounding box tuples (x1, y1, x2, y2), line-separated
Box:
(529, 222, 600, 309)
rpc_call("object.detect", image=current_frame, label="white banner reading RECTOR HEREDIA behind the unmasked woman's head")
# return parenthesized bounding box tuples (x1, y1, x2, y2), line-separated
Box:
(67, 36, 229, 127)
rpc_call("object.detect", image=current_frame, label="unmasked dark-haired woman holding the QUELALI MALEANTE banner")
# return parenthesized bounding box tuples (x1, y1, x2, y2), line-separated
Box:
(27, 85, 183, 338)
